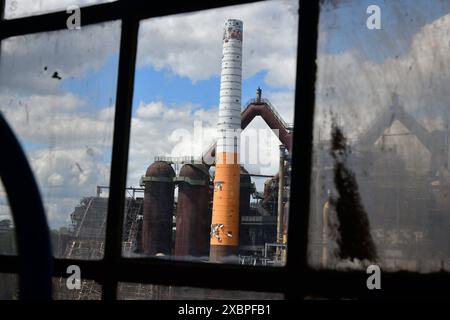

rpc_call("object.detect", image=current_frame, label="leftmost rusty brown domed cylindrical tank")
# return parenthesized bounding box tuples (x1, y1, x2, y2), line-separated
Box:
(142, 161, 175, 255)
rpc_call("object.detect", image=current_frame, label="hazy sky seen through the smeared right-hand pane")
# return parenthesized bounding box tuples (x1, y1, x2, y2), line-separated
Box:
(316, 0, 450, 137)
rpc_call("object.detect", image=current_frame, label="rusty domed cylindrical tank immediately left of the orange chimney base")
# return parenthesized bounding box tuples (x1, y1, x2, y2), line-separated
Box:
(175, 164, 211, 257)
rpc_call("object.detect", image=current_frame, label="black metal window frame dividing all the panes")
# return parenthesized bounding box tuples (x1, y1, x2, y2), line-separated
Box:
(0, 0, 450, 300)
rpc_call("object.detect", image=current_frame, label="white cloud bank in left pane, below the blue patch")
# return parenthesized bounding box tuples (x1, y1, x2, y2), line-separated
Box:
(0, 93, 114, 227)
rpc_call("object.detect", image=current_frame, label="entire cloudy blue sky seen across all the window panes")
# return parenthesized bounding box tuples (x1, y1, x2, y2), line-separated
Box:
(0, 0, 450, 232)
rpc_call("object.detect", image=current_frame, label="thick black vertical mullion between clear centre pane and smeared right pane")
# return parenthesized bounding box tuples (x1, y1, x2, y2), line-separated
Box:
(286, 1, 319, 298)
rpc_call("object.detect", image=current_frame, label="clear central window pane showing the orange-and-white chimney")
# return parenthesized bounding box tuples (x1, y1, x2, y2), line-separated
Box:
(123, 1, 298, 266)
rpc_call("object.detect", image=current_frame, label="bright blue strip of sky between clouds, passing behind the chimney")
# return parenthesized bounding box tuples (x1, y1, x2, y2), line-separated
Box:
(60, 54, 289, 115)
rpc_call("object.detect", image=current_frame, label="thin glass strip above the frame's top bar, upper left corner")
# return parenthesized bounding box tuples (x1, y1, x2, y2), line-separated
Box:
(4, 0, 116, 19)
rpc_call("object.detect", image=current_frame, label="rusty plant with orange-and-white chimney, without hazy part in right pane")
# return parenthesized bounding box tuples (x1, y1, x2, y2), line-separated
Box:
(51, 19, 293, 299)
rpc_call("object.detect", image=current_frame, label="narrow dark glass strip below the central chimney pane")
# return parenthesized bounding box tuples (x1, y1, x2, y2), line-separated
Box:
(117, 282, 284, 300)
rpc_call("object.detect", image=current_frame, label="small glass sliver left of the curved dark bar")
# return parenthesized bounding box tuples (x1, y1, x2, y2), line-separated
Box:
(0, 179, 17, 255)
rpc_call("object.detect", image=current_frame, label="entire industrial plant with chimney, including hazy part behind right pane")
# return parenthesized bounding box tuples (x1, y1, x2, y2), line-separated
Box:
(49, 19, 450, 299)
